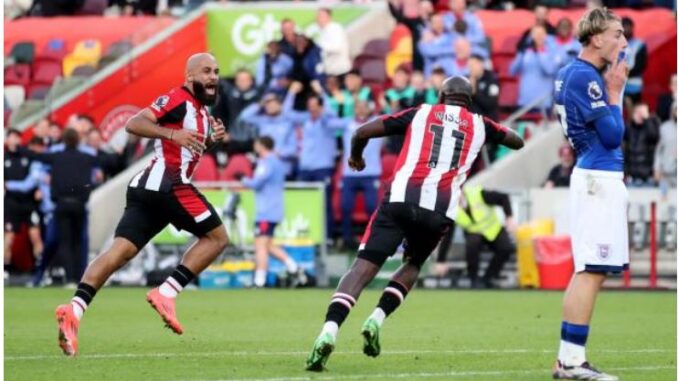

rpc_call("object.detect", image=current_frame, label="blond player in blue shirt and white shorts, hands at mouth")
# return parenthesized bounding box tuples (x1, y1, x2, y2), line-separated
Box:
(553, 8, 629, 381)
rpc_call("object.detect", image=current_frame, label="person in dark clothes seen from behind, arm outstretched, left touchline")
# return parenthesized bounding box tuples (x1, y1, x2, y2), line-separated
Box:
(31, 128, 98, 283)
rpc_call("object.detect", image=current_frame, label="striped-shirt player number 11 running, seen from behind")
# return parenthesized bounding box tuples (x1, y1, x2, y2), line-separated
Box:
(306, 77, 523, 371)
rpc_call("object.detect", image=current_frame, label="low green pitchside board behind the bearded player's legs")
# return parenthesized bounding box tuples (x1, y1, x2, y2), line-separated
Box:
(152, 187, 325, 245)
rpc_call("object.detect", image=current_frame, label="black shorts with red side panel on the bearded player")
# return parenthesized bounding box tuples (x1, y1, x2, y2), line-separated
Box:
(115, 184, 222, 250)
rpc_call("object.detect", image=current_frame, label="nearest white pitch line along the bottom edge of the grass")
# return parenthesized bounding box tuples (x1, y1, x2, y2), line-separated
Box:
(194, 365, 675, 381)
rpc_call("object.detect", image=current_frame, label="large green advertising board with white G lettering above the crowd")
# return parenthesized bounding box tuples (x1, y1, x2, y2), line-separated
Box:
(207, 3, 369, 76)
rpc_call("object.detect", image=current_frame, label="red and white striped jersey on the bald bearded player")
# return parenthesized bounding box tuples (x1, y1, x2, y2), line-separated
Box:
(130, 86, 209, 192)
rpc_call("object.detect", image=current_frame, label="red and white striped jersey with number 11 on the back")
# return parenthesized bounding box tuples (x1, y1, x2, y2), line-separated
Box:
(382, 104, 506, 219)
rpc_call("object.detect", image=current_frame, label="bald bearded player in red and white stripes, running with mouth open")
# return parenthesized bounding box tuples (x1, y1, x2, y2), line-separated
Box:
(56, 53, 228, 356)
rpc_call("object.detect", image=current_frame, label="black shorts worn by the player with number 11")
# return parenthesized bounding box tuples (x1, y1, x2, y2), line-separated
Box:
(358, 202, 454, 267)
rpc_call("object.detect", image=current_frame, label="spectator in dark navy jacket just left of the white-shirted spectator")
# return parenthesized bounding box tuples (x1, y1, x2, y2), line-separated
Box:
(290, 34, 324, 110)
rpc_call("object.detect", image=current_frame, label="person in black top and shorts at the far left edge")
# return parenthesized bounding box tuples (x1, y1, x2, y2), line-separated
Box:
(4, 128, 42, 271)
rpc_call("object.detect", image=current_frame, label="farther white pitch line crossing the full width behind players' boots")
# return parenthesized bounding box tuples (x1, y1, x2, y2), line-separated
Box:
(5, 348, 675, 361)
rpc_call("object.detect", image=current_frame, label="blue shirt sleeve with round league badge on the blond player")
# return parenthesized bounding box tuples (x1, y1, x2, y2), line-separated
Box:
(566, 71, 610, 123)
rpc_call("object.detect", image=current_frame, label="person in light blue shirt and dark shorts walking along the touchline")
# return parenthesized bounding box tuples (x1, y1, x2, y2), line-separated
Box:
(242, 136, 304, 287)
